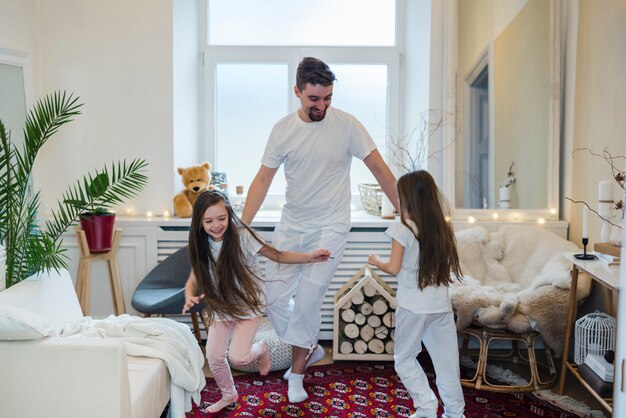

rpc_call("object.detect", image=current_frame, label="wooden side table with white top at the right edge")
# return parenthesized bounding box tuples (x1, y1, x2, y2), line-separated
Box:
(558, 253, 620, 413)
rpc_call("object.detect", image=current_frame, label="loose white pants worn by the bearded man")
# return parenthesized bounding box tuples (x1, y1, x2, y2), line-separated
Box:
(265, 225, 347, 348)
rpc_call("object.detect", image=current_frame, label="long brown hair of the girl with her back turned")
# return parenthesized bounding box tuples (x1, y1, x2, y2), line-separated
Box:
(398, 170, 461, 289)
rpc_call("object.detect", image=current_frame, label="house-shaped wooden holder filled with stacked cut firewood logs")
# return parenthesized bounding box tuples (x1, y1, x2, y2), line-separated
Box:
(333, 266, 396, 360)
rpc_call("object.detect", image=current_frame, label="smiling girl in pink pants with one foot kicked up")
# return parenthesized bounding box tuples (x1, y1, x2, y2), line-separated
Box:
(182, 190, 330, 413)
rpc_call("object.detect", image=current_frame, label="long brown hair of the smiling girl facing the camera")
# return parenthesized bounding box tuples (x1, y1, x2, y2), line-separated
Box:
(189, 190, 279, 321)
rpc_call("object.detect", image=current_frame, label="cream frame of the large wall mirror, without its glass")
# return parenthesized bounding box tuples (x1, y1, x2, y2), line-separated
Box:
(443, 0, 561, 221)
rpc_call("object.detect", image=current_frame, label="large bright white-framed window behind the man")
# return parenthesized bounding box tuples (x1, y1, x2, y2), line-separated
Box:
(204, 0, 402, 201)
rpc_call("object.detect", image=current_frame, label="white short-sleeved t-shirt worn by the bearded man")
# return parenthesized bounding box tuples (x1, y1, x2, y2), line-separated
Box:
(262, 107, 376, 233)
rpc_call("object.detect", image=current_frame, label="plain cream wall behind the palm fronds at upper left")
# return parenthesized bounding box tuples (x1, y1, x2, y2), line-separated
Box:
(0, 0, 174, 213)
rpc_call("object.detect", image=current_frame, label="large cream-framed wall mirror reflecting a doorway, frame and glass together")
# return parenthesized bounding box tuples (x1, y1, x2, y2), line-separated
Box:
(444, 0, 560, 219)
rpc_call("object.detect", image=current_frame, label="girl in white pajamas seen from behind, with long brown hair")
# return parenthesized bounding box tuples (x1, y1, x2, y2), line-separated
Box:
(368, 170, 465, 418)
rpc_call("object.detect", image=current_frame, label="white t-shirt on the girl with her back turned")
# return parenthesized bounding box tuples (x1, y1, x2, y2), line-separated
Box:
(385, 221, 452, 314)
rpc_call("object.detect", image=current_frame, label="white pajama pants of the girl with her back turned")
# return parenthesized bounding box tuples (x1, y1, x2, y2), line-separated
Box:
(393, 307, 465, 418)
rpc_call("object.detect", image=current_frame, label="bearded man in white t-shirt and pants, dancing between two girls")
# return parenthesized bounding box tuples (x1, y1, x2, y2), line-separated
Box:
(242, 57, 398, 403)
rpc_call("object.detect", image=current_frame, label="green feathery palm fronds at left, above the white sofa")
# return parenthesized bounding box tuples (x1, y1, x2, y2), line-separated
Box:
(0, 92, 147, 288)
